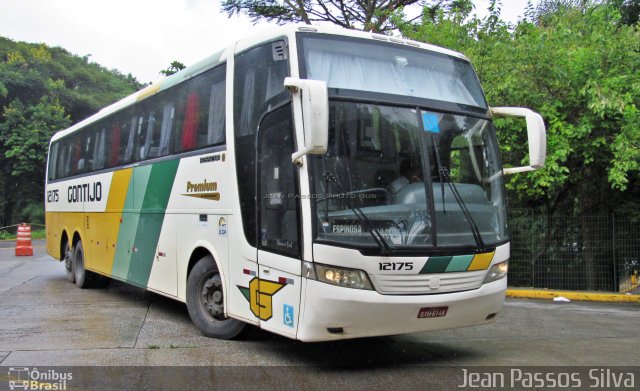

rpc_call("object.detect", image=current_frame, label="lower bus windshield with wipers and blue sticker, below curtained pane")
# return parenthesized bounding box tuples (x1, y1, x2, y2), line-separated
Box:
(310, 101, 507, 250)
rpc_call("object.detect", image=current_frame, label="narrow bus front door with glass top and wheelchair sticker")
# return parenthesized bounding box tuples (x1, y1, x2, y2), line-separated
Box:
(252, 105, 302, 337)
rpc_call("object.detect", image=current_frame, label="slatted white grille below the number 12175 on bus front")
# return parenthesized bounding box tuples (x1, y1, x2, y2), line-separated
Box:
(371, 270, 487, 295)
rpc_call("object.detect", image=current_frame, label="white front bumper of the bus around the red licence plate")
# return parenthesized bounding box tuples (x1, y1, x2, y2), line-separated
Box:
(297, 278, 507, 342)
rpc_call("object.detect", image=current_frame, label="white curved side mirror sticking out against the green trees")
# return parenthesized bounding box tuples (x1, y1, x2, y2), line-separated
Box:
(491, 107, 547, 175)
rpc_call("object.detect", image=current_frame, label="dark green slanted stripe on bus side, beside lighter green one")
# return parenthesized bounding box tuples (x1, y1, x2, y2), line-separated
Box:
(127, 160, 179, 286)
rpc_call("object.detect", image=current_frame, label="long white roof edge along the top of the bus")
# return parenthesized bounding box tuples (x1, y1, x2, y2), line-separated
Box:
(51, 24, 468, 141)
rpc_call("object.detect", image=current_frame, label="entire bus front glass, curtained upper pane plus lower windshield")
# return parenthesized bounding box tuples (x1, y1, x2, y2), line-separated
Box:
(301, 35, 508, 254)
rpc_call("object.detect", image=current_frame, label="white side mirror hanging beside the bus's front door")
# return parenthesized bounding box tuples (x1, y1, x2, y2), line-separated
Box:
(284, 77, 329, 166)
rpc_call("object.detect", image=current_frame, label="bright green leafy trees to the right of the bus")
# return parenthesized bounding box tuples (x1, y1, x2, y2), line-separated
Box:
(401, 0, 640, 213)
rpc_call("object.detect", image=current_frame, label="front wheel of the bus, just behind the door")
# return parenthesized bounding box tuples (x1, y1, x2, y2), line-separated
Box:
(187, 255, 246, 339)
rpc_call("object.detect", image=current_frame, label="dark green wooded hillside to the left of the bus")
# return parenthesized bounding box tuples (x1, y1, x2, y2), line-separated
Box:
(0, 37, 142, 224)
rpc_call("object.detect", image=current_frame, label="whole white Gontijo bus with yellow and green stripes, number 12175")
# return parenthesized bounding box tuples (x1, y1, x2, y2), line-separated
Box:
(45, 26, 545, 341)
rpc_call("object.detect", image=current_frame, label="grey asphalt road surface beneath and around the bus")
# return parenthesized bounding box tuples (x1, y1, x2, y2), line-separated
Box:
(0, 241, 640, 388)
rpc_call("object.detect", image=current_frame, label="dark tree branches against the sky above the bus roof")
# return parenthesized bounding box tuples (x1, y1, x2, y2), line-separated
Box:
(221, 0, 464, 33)
